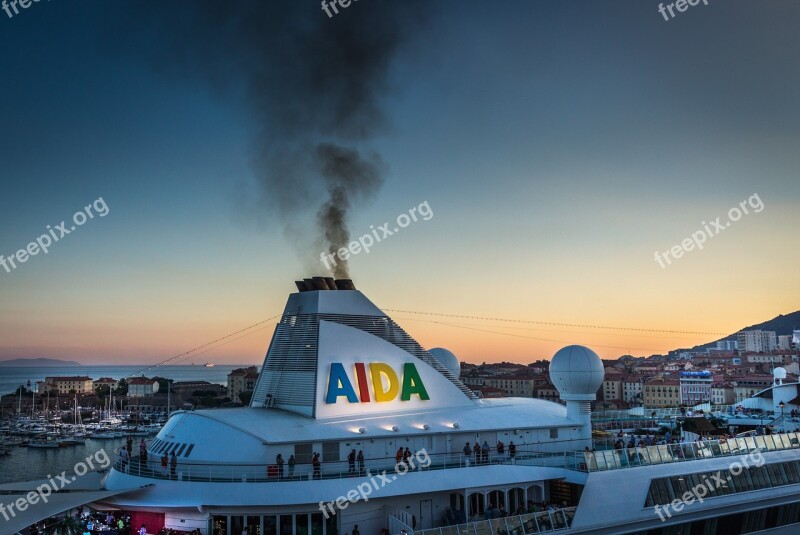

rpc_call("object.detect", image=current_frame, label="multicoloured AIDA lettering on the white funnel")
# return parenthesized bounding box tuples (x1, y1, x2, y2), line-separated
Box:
(325, 362, 430, 403)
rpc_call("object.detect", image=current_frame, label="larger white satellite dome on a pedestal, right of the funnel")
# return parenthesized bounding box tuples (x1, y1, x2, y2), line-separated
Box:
(550, 345, 605, 401)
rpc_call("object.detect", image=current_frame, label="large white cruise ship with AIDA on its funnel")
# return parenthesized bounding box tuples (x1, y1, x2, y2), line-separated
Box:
(0, 277, 800, 535)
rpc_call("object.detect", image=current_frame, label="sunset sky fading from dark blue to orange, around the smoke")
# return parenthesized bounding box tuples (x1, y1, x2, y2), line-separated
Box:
(0, 0, 800, 364)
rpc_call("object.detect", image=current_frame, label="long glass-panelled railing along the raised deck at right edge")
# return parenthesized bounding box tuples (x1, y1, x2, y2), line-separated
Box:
(582, 433, 800, 472)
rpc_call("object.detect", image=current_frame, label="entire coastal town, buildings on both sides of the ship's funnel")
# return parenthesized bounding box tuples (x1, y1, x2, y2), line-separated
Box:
(2, 329, 800, 415)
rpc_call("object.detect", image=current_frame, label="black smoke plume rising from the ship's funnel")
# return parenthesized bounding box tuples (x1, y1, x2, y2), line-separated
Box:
(111, 0, 427, 277)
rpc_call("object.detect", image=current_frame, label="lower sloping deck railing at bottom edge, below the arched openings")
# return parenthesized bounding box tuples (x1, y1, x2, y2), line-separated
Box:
(410, 507, 576, 535)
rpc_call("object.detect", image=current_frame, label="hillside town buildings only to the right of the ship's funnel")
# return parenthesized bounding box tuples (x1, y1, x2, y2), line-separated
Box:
(461, 330, 800, 411)
